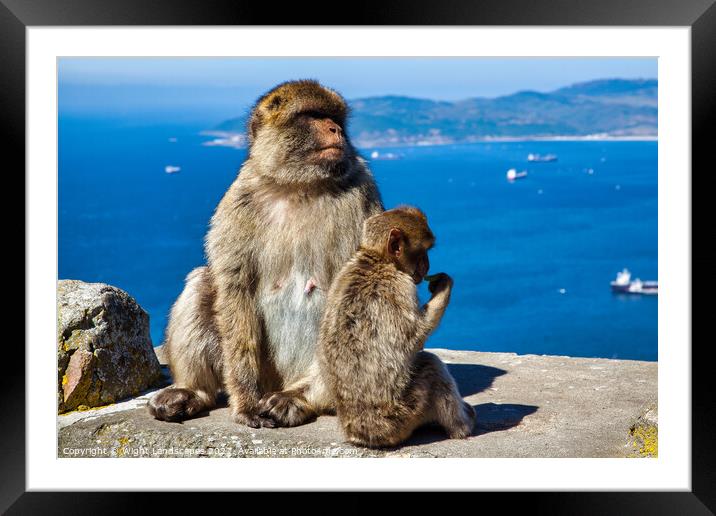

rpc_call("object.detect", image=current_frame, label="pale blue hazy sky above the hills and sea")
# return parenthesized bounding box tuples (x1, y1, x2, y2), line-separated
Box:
(58, 57, 657, 124)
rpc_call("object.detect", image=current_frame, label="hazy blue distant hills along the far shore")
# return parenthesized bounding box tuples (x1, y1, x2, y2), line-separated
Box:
(207, 79, 658, 147)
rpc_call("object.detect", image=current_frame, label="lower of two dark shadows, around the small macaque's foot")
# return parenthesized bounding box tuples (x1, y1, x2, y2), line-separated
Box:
(402, 403, 539, 449)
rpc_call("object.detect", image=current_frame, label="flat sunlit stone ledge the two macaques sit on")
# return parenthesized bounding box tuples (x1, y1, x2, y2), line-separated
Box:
(58, 349, 657, 458)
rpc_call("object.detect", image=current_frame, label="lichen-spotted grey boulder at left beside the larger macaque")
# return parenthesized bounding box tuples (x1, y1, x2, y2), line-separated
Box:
(57, 280, 161, 413)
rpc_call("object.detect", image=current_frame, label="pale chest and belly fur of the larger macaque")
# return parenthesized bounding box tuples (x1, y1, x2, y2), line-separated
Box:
(258, 188, 363, 385)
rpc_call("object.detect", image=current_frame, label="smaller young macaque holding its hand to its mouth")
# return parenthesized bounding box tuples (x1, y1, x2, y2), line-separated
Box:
(318, 207, 475, 447)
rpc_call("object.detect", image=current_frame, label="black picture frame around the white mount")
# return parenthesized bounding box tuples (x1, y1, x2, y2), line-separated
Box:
(5, 0, 716, 515)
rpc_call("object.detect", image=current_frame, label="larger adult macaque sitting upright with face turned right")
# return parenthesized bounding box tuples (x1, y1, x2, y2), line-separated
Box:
(149, 81, 382, 428)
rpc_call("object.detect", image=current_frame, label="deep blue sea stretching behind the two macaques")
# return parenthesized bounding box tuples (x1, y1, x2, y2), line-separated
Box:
(58, 116, 658, 360)
